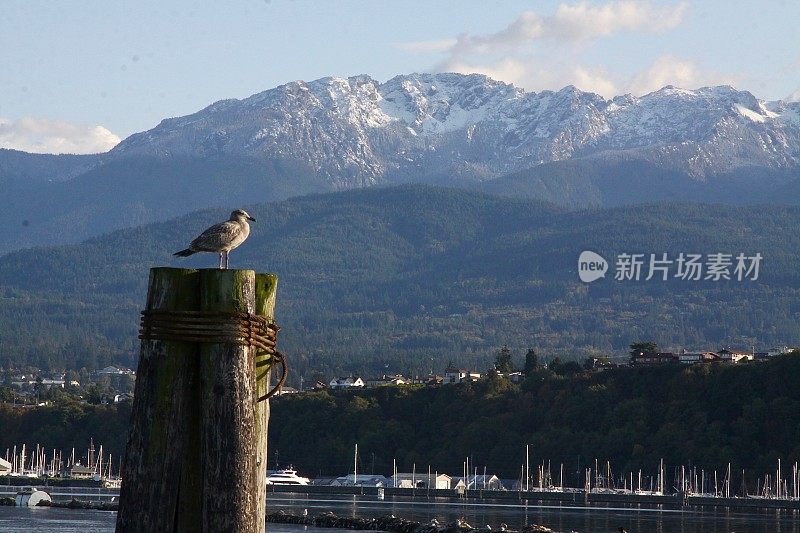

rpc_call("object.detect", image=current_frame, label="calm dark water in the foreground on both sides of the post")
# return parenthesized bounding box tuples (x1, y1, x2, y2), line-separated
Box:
(0, 494, 800, 533)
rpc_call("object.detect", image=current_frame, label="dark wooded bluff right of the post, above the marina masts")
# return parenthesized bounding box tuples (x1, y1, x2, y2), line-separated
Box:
(269, 355, 800, 492)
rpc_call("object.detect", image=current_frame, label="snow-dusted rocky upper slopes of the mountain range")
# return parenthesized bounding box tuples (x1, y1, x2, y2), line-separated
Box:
(114, 74, 800, 188)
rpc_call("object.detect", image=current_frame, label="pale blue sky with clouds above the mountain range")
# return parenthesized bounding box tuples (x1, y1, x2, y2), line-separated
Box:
(0, 0, 800, 153)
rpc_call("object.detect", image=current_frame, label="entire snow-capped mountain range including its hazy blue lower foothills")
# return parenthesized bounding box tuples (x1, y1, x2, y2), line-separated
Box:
(0, 74, 800, 254)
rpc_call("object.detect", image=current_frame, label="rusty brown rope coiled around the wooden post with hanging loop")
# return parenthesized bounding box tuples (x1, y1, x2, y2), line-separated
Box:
(139, 309, 288, 402)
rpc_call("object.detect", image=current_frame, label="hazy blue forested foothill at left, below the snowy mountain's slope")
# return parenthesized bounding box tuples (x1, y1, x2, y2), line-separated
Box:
(0, 154, 329, 254)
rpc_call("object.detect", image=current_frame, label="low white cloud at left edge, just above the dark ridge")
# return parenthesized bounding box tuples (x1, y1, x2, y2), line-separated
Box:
(0, 117, 121, 154)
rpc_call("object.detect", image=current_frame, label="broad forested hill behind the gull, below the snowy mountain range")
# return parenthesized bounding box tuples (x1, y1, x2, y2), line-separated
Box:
(0, 185, 800, 380)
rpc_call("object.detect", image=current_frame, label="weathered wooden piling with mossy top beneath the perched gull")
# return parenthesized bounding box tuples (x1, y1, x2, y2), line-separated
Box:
(117, 268, 277, 533)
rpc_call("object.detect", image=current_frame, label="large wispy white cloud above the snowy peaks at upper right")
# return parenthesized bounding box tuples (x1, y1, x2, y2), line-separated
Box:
(418, 0, 733, 98)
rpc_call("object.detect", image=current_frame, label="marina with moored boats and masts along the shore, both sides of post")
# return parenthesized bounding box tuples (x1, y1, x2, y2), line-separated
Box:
(0, 454, 800, 511)
